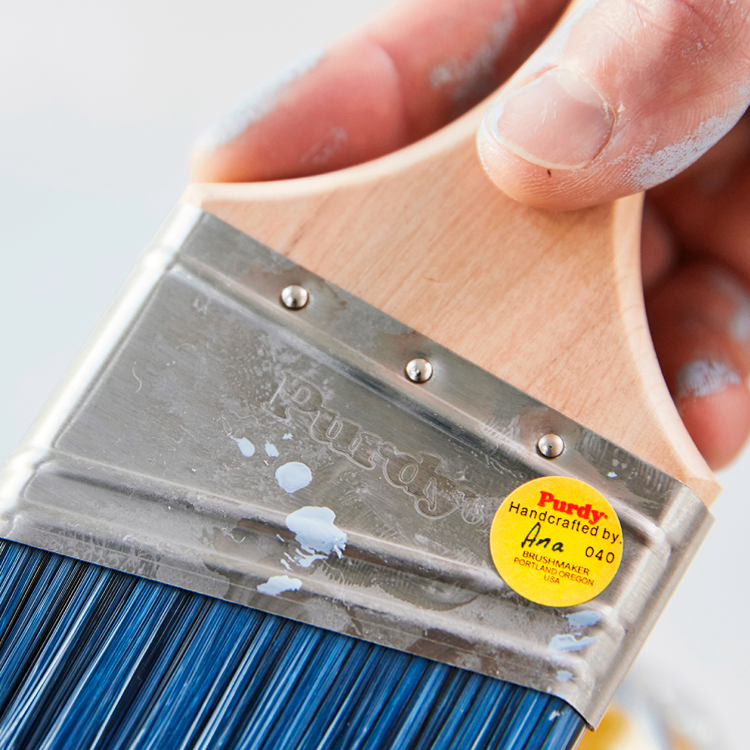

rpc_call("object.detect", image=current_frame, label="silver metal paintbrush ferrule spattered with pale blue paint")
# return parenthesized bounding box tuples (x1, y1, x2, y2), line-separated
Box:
(0, 206, 710, 724)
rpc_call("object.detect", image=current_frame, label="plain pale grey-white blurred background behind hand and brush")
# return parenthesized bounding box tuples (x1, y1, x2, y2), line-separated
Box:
(0, 0, 750, 750)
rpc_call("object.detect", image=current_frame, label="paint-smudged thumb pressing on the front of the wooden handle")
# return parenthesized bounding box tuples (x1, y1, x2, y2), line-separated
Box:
(478, 0, 750, 209)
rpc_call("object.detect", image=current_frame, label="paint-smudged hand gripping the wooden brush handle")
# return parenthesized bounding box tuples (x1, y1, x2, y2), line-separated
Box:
(192, 0, 750, 468)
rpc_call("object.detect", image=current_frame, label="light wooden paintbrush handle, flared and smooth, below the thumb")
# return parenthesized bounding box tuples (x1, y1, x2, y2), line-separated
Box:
(183, 104, 719, 504)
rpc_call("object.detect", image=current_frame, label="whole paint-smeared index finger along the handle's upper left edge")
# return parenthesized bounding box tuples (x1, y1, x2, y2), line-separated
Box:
(191, 0, 565, 182)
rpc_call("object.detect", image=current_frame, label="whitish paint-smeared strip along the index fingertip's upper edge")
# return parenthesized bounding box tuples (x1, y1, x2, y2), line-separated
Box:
(193, 51, 323, 151)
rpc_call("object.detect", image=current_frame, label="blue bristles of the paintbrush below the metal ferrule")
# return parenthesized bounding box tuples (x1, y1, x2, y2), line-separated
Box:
(0, 542, 585, 750)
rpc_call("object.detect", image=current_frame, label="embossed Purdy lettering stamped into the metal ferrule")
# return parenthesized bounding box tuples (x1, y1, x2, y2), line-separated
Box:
(263, 372, 484, 524)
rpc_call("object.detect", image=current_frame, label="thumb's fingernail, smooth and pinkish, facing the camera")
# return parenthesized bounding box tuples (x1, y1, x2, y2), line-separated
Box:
(485, 68, 614, 169)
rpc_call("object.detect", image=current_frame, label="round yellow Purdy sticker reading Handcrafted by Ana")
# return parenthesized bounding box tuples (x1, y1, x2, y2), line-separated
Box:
(490, 477, 622, 607)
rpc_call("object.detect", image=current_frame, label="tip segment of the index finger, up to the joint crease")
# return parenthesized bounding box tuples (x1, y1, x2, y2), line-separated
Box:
(191, 38, 407, 182)
